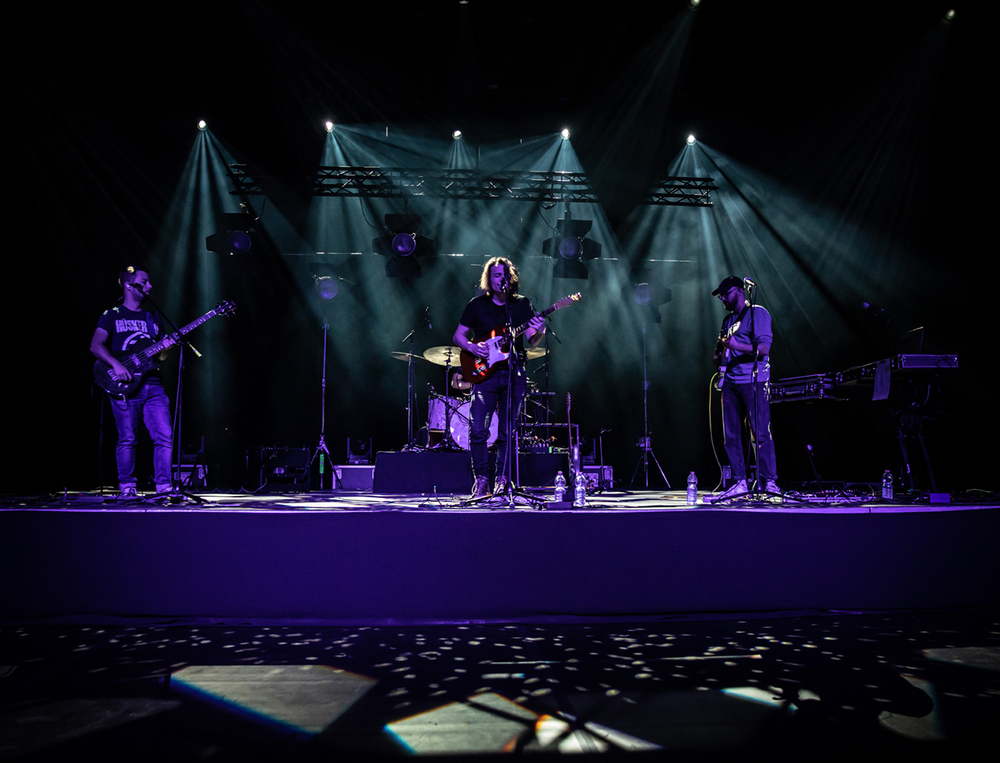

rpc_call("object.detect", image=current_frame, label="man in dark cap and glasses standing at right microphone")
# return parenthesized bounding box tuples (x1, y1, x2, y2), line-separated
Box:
(712, 276, 780, 501)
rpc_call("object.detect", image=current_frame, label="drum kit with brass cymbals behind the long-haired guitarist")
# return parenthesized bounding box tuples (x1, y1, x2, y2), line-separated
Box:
(389, 345, 547, 450)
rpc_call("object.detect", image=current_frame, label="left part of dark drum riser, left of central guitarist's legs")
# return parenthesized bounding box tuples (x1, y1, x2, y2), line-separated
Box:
(373, 451, 472, 493)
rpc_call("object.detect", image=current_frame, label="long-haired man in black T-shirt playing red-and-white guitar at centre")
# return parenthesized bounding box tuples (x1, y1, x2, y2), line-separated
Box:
(453, 257, 545, 497)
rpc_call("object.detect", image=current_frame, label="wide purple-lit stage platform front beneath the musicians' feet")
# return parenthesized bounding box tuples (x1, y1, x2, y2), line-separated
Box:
(0, 491, 1000, 622)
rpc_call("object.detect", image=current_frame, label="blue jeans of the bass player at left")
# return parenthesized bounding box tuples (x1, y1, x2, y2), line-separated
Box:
(111, 379, 173, 492)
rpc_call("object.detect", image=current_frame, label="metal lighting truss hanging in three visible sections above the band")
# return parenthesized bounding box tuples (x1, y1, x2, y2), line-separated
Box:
(227, 164, 717, 207)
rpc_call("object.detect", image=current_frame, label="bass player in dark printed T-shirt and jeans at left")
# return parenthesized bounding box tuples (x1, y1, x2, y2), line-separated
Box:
(90, 267, 174, 499)
